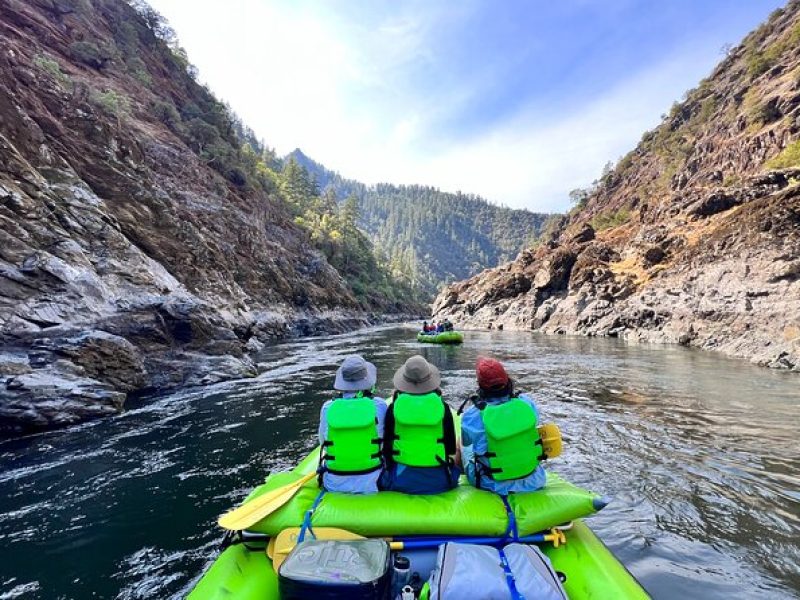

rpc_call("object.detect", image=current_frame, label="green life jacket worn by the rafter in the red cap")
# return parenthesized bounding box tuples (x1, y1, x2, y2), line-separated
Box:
(481, 398, 544, 481)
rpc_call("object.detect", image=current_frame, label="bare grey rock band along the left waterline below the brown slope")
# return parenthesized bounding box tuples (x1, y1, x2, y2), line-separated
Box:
(0, 296, 422, 437)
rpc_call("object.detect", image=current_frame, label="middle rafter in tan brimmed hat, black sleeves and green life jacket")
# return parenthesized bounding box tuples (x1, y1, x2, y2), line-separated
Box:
(380, 356, 459, 494)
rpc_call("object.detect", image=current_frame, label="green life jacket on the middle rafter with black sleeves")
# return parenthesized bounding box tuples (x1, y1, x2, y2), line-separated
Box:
(392, 392, 447, 467)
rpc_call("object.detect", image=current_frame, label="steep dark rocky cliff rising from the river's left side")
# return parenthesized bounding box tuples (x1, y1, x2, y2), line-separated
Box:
(0, 0, 398, 432)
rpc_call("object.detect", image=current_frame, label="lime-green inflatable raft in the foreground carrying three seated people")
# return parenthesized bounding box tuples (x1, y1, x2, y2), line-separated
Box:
(189, 451, 649, 600)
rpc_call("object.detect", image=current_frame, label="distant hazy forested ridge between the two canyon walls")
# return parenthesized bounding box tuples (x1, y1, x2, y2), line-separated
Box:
(286, 149, 552, 298)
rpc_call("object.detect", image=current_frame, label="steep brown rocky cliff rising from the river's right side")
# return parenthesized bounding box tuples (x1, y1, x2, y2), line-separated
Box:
(433, 1, 800, 370)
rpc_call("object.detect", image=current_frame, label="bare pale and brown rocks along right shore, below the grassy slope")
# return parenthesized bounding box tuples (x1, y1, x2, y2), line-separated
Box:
(433, 170, 800, 371)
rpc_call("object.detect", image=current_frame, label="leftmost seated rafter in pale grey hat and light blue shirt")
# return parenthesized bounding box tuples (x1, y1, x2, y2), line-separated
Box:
(319, 355, 386, 494)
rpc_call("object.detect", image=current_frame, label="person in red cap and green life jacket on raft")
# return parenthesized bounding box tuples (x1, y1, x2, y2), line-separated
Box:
(461, 357, 546, 495)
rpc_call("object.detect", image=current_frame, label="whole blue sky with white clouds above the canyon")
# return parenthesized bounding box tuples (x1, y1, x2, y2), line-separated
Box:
(151, 0, 783, 211)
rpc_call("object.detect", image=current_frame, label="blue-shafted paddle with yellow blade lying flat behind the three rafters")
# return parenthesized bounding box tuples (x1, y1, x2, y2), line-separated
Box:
(267, 527, 566, 571)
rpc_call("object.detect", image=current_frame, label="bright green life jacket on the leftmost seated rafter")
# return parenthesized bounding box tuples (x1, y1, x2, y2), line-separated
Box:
(322, 398, 381, 475)
